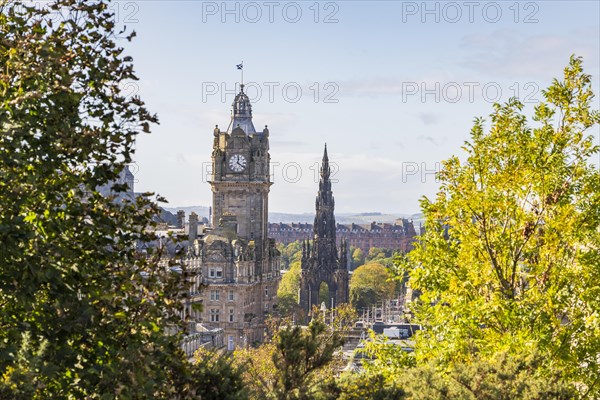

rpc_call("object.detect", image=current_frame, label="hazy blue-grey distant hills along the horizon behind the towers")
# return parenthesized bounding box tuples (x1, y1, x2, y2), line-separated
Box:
(165, 206, 423, 227)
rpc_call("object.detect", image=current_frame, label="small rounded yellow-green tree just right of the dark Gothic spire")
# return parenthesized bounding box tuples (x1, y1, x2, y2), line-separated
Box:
(350, 263, 396, 310)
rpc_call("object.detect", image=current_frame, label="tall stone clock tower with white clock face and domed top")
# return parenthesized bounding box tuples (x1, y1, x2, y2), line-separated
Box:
(198, 85, 280, 350)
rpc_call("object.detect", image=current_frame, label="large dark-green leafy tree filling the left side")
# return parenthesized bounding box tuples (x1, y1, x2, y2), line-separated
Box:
(0, 0, 202, 399)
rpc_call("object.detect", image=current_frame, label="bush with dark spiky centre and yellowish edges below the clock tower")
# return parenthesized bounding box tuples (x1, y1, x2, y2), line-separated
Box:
(234, 306, 356, 400)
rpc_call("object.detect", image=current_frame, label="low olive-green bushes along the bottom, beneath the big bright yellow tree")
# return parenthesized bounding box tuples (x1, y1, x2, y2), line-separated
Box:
(350, 340, 577, 400)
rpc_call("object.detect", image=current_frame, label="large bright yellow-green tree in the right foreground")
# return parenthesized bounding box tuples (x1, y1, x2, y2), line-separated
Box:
(400, 57, 600, 398)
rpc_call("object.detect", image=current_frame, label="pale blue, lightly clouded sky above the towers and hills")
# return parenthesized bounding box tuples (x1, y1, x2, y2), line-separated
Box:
(118, 0, 600, 214)
